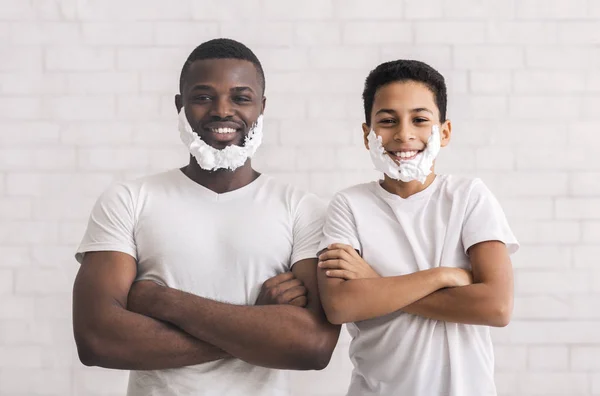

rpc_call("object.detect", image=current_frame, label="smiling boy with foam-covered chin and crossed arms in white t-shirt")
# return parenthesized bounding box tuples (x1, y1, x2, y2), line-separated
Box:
(318, 60, 518, 396)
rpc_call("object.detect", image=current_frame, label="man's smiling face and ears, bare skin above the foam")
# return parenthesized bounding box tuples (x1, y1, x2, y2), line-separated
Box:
(175, 59, 265, 149)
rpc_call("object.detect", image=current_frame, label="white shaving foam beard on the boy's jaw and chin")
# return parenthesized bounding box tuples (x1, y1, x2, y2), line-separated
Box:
(367, 125, 441, 183)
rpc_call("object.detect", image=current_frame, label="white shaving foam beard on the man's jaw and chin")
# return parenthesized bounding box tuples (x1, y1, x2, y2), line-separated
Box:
(179, 107, 263, 171)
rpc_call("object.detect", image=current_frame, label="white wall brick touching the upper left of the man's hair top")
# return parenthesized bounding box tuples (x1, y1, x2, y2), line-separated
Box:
(154, 21, 219, 46)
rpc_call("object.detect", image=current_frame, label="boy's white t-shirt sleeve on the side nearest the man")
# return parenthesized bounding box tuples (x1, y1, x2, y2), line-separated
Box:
(319, 194, 362, 252)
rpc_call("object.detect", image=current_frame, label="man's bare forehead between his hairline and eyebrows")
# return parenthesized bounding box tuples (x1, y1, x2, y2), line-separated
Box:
(183, 59, 261, 93)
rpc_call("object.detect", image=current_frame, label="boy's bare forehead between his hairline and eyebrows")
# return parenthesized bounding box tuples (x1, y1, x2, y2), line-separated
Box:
(373, 81, 439, 112)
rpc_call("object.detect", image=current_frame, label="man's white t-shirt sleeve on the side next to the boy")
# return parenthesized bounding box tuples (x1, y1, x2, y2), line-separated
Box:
(290, 194, 327, 266)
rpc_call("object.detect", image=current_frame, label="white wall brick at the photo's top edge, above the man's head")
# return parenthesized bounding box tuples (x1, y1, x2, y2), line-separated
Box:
(191, 0, 263, 20)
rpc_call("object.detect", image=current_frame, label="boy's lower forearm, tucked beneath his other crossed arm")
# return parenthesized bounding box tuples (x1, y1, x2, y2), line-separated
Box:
(402, 283, 512, 327)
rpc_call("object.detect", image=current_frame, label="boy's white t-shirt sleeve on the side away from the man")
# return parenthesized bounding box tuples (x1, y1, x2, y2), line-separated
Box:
(462, 179, 519, 254)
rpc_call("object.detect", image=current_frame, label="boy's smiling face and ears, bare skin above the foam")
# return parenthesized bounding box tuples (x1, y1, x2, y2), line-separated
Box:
(362, 81, 452, 164)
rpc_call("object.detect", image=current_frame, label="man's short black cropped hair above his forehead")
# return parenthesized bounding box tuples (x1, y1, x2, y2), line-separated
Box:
(179, 38, 265, 93)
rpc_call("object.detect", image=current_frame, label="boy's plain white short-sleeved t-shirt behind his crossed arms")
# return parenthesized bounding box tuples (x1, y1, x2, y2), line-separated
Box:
(320, 175, 518, 396)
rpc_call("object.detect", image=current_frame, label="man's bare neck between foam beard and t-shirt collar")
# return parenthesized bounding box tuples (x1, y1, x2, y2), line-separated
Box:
(181, 156, 260, 194)
